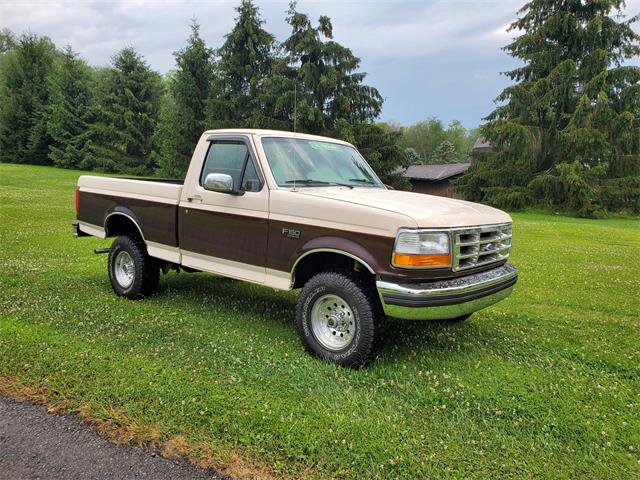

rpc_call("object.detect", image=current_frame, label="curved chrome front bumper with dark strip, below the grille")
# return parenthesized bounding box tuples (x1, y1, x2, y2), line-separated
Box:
(376, 264, 518, 320)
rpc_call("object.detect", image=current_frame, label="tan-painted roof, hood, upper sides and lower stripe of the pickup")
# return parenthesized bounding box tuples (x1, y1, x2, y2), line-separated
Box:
(78, 129, 511, 290)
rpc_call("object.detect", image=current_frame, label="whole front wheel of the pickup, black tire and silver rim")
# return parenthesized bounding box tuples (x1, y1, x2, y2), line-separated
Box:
(296, 272, 385, 368)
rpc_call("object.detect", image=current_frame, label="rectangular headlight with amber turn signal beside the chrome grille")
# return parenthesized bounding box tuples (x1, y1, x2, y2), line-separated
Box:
(392, 230, 451, 268)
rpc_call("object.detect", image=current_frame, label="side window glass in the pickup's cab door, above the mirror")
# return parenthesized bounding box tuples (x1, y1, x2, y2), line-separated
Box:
(200, 140, 262, 192)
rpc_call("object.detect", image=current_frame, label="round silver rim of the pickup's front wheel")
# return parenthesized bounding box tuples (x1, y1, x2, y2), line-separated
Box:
(311, 295, 356, 351)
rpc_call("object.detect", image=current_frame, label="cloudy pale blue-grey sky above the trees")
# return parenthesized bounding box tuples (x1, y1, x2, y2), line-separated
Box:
(0, 0, 640, 127)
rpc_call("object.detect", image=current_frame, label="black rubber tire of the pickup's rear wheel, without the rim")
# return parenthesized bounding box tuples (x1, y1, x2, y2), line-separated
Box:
(107, 235, 160, 300)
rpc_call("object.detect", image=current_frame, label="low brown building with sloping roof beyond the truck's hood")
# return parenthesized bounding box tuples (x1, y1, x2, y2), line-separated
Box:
(402, 163, 471, 198)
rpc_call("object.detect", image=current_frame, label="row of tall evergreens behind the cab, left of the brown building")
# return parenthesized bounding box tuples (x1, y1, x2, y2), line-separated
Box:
(0, 0, 407, 187)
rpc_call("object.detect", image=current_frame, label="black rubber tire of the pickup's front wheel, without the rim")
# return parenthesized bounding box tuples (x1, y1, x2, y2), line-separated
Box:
(296, 272, 386, 368)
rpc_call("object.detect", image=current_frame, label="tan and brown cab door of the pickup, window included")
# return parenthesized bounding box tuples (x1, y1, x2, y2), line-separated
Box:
(178, 135, 269, 283)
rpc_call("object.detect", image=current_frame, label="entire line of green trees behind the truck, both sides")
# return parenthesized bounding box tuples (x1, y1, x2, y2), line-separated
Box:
(0, 0, 640, 216)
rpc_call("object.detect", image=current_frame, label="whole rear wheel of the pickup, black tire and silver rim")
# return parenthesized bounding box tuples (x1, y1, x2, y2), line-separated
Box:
(107, 235, 160, 300)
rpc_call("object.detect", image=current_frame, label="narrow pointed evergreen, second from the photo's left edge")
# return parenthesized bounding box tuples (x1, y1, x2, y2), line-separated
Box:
(47, 46, 93, 168)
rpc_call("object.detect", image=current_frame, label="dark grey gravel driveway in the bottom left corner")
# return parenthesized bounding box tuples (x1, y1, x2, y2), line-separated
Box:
(0, 397, 227, 480)
